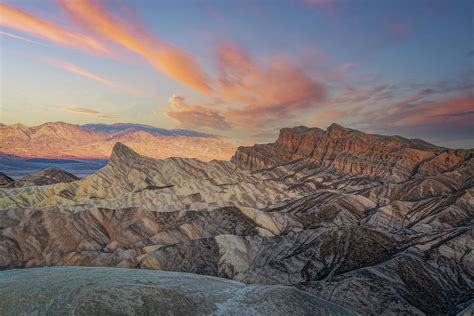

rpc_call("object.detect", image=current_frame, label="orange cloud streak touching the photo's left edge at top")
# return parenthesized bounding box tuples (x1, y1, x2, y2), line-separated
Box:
(0, 4, 112, 56)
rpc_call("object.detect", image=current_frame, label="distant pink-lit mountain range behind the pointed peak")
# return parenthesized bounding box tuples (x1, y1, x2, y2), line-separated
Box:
(0, 122, 241, 161)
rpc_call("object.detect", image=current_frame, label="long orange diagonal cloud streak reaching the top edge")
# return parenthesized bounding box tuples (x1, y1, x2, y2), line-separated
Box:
(60, 0, 210, 94)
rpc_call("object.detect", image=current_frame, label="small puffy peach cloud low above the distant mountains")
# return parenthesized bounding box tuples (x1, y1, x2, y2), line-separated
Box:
(166, 95, 231, 130)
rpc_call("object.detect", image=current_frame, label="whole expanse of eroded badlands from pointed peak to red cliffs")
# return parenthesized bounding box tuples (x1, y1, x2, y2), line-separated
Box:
(0, 125, 474, 315)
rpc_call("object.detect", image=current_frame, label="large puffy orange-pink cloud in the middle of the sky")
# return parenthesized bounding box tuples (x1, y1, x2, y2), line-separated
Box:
(218, 43, 326, 127)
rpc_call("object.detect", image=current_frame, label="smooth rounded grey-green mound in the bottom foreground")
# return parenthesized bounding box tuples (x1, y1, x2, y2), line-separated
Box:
(0, 267, 354, 316)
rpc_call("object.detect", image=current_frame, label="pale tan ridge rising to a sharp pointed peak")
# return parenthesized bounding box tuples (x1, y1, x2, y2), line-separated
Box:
(0, 143, 300, 211)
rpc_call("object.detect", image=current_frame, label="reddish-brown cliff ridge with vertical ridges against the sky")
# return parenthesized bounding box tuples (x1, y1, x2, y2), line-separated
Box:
(231, 124, 472, 182)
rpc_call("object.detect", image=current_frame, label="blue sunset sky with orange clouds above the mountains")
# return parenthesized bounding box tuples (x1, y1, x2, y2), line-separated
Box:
(0, 0, 474, 148)
